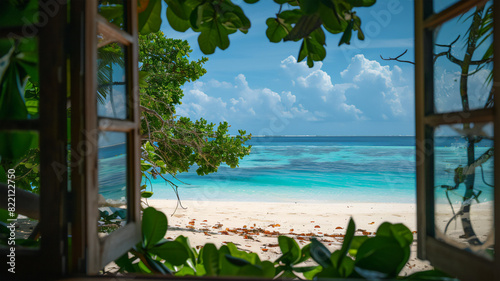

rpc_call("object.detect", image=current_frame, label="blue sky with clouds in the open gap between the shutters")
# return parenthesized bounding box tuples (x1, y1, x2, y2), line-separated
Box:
(161, 0, 414, 136)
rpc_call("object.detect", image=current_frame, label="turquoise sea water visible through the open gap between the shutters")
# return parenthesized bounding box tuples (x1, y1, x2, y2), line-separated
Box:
(153, 137, 415, 202)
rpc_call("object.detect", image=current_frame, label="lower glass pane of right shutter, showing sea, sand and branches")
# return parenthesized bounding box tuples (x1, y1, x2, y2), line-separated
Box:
(434, 123, 495, 259)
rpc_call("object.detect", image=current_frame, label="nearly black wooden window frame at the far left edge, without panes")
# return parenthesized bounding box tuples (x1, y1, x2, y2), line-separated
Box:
(0, 0, 68, 278)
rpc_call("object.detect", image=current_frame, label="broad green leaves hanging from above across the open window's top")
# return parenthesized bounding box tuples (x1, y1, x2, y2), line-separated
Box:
(132, 0, 376, 67)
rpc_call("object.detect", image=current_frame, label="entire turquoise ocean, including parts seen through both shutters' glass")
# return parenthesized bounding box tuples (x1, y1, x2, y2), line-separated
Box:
(99, 136, 493, 203)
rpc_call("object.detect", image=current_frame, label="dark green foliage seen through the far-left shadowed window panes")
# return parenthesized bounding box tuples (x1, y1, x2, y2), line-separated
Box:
(0, 36, 40, 192)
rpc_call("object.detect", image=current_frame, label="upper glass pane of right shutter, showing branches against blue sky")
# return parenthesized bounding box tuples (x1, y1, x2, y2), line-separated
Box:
(434, 1, 493, 113)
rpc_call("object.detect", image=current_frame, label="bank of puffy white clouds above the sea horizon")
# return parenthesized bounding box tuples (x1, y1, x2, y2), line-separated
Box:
(177, 55, 413, 134)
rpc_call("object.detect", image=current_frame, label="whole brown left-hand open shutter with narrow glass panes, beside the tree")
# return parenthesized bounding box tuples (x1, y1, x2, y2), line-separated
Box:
(71, 0, 141, 274)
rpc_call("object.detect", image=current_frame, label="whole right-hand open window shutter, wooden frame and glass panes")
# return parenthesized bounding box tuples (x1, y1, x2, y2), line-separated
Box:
(415, 0, 500, 280)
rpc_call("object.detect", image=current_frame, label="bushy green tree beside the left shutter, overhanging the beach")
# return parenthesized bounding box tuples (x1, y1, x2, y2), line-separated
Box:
(139, 32, 251, 197)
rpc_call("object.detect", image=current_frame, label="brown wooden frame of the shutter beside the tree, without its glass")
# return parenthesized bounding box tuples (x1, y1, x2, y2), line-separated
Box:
(71, 0, 141, 274)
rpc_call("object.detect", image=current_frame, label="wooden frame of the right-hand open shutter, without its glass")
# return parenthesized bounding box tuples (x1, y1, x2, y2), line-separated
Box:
(415, 0, 500, 280)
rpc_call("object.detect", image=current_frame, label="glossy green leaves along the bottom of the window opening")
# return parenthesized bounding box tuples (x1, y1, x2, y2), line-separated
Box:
(116, 207, 455, 280)
